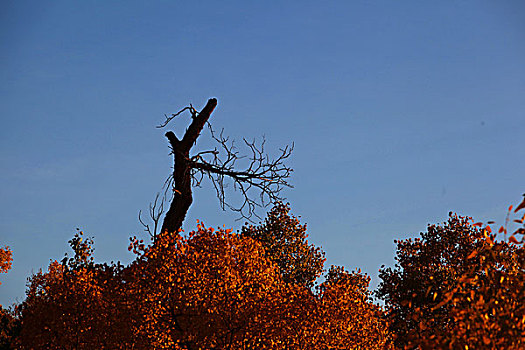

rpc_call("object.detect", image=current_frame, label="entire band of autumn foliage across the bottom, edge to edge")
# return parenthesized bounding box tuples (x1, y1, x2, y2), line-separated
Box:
(0, 197, 525, 350)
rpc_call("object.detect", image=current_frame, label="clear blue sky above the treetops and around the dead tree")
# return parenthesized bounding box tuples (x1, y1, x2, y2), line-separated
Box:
(0, 0, 525, 306)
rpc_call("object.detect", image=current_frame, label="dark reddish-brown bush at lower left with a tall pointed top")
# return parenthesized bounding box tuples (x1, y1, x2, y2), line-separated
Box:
(18, 232, 133, 349)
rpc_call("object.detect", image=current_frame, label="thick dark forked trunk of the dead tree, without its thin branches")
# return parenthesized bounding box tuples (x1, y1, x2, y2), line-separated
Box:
(162, 98, 217, 233)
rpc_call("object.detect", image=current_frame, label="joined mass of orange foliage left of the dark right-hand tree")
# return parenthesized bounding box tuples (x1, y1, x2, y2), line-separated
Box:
(4, 204, 389, 350)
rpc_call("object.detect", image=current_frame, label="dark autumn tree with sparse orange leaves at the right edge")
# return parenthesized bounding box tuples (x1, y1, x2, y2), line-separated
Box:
(376, 201, 525, 349)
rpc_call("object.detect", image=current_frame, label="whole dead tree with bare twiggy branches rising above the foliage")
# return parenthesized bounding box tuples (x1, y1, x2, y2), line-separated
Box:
(139, 98, 293, 239)
